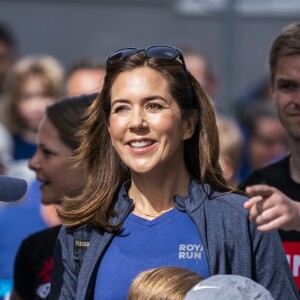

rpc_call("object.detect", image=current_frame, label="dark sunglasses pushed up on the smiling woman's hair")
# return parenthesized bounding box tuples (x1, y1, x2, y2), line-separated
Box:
(106, 46, 188, 74)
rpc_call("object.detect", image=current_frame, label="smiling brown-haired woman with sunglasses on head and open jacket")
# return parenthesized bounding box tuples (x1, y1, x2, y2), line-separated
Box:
(50, 46, 298, 300)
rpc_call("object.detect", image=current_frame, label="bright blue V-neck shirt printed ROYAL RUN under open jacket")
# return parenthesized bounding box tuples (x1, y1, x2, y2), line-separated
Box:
(94, 209, 209, 300)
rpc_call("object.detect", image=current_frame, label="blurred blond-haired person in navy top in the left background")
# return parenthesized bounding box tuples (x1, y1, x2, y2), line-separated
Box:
(3, 55, 64, 180)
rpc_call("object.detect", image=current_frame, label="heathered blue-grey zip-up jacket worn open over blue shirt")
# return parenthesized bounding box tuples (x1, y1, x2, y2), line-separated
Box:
(50, 180, 300, 300)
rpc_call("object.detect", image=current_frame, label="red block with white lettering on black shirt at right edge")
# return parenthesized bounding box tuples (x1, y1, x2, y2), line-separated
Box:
(282, 242, 300, 290)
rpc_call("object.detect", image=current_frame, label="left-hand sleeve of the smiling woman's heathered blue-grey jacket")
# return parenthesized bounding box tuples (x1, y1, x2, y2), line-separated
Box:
(50, 226, 77, 300)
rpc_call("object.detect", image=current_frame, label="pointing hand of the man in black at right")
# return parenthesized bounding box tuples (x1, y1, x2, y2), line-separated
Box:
(244, 184, 300, 232)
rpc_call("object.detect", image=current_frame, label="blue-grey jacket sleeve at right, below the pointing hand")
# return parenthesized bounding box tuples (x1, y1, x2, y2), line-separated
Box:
(250, 219, 300, 300)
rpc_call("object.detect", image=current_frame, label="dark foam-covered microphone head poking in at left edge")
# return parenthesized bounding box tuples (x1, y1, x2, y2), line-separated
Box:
(0, 175, 27, 202)
